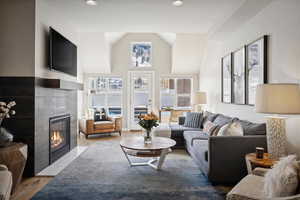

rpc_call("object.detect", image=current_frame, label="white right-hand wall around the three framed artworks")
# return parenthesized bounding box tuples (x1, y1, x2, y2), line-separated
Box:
(199, 0, 300, 156)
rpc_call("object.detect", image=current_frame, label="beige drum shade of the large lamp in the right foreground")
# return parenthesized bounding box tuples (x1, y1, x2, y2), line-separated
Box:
(255, 83, 300, 114)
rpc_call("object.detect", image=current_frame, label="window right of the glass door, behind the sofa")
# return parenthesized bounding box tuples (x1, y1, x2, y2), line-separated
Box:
(160, 77, 192, 108)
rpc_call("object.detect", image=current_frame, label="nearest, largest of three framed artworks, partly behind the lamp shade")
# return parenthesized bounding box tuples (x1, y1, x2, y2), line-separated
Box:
(246, 36, 268, 105)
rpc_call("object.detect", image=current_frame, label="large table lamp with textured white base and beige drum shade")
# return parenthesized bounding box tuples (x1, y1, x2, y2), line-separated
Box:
(255, 83, 300, 159)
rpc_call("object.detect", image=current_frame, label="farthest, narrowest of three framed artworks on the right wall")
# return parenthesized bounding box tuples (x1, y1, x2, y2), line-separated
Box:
(221, 54, 232, 103)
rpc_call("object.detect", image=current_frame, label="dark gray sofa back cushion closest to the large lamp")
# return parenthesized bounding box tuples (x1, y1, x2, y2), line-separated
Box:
(238, 120, 267, 135)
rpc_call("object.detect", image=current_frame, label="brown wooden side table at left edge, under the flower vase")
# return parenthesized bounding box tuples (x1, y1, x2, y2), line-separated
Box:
(0, 143, 28, 193)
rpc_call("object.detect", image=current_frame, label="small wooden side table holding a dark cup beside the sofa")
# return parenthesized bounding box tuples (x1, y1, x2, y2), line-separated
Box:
(245, 153, 278, 174)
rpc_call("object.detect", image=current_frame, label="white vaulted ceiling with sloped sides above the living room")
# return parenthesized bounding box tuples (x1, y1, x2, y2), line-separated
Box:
(39, 0, 273, 73)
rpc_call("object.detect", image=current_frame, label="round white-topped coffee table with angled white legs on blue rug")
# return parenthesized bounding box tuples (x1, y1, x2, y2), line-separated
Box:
(120, 137, 176, 170)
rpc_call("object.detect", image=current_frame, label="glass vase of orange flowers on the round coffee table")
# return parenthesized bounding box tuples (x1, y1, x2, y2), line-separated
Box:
(138, 112, 159, 144)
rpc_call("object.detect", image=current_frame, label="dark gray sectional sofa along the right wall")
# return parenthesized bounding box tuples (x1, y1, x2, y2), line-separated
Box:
(171, 112, 267, 184)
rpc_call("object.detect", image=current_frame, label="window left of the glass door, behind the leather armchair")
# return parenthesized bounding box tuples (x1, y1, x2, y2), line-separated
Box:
(89, 76, 123, 116)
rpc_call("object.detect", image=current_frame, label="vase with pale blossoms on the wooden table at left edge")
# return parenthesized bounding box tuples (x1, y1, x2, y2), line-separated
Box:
(0, 101, 16, 147)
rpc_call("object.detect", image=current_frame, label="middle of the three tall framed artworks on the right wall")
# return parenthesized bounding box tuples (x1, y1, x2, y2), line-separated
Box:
(232, 47, 246, 104)
